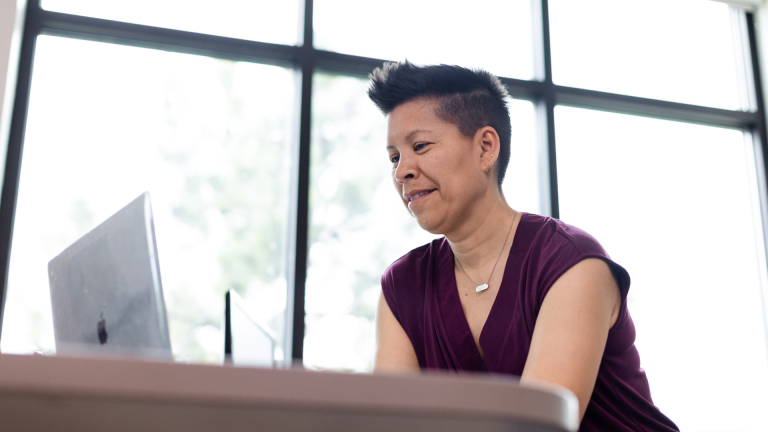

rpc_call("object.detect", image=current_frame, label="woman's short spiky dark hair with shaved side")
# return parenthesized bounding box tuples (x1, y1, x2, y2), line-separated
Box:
(368, 60, 512, 187)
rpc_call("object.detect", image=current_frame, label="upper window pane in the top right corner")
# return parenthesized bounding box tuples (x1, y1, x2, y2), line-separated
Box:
(549, 0, 741, 109)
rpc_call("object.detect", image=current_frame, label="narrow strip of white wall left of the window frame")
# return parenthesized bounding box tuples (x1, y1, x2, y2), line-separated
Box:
(0, 0, 26, 185)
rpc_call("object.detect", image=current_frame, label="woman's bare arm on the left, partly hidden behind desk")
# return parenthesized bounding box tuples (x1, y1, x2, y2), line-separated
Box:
(373, 293, 420, 372)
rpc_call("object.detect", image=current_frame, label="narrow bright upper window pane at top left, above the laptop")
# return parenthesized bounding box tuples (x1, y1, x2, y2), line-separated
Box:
(42, 0, 303, 45)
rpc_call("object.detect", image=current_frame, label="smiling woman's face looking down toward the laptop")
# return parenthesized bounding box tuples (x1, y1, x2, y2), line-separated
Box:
(387, 99, 488, 234)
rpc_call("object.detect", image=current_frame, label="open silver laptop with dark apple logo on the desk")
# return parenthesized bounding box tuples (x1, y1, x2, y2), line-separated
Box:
(48, 192, 173, 361)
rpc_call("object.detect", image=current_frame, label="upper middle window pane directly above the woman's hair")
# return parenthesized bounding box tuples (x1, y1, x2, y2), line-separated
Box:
(314, 0, 533, 79)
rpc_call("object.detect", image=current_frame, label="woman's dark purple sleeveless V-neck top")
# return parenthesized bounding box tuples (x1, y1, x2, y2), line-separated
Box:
(381, 213, 678, 431)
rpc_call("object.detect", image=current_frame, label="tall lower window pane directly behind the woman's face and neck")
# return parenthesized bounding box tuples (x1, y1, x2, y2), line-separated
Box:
(304, 74, 538, 371)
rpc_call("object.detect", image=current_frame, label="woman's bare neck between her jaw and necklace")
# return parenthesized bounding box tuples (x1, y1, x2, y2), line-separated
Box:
(445, 194, 519, 269)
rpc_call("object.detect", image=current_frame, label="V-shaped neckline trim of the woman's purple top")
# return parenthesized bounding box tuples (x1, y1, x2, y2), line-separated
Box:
(439, 212, 527, 371)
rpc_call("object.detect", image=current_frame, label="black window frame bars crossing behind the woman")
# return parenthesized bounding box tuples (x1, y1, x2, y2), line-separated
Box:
(0, 0, 768, 366)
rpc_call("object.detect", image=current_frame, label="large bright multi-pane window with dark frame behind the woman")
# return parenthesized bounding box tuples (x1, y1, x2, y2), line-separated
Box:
(0, 0, 768, 431)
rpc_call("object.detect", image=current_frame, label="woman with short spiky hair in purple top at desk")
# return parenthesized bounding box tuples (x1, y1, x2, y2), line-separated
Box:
(369, 62, 677, 431)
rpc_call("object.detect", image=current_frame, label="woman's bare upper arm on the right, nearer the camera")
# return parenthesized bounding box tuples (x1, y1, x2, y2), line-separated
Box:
(522, 258, 621, 419)
